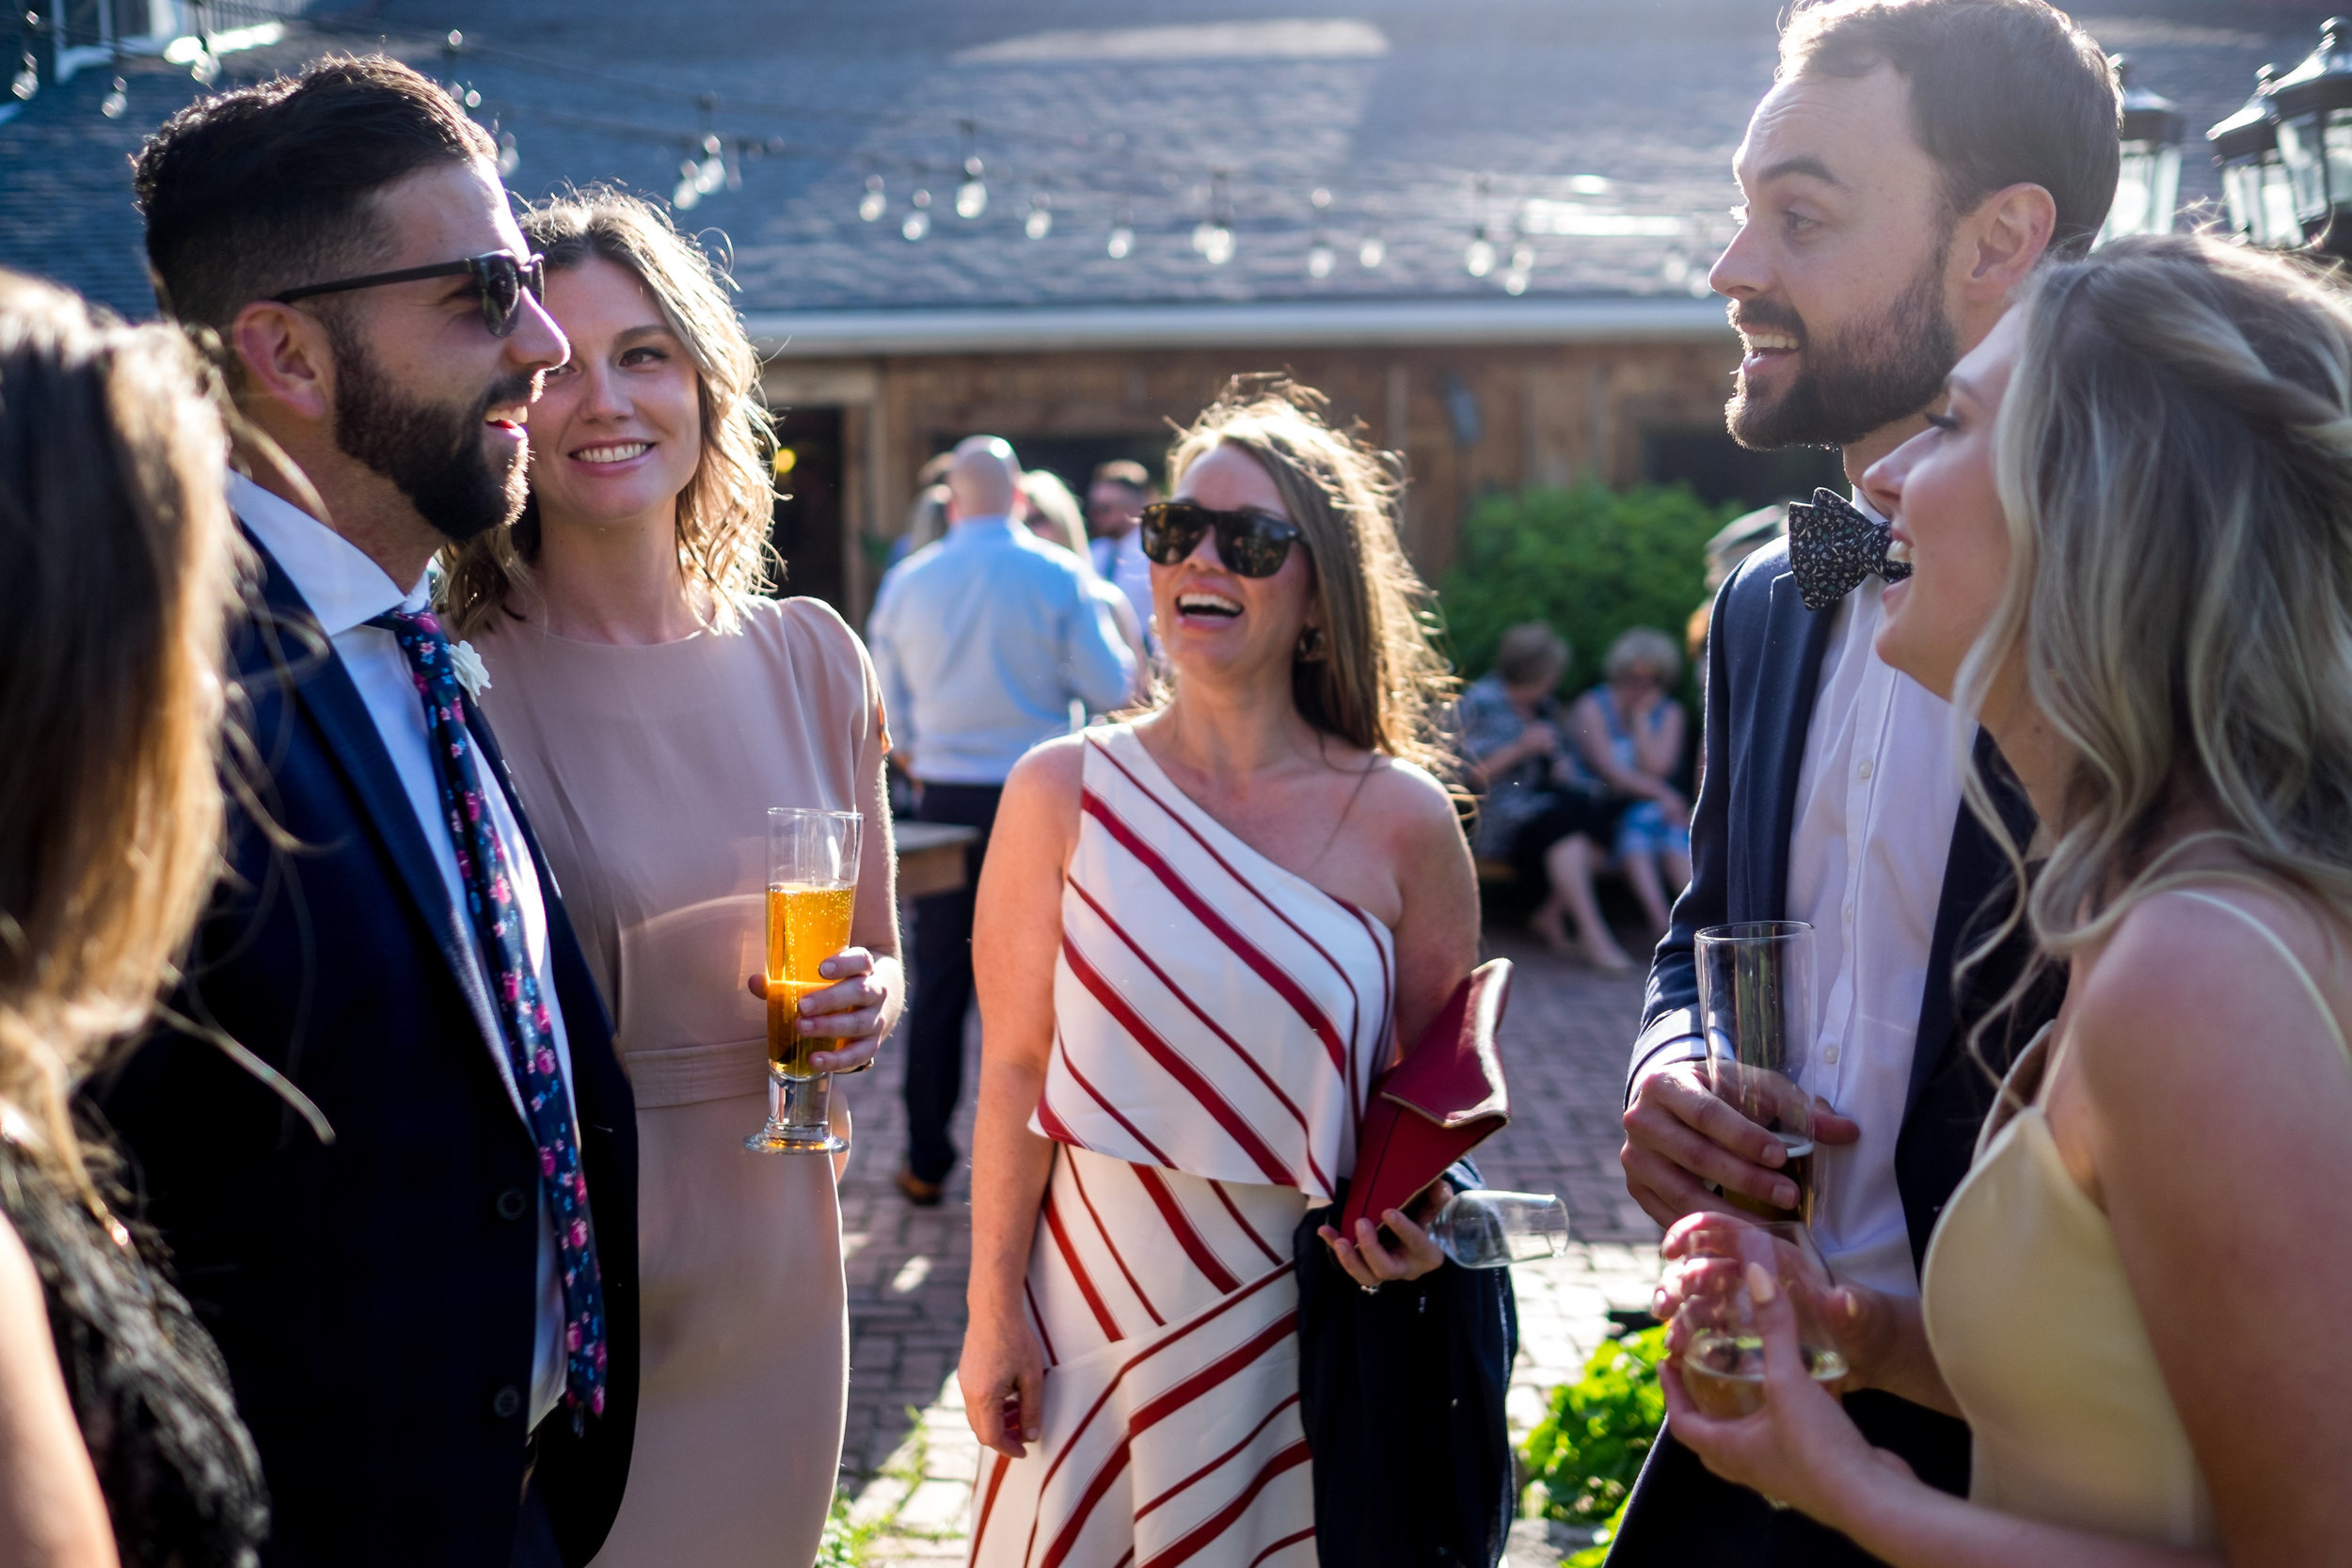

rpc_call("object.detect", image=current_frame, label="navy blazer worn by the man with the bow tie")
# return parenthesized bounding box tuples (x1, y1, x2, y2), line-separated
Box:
(1626, 541, 2056, 1267)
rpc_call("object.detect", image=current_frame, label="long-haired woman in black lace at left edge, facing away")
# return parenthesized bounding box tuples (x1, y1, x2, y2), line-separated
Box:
(0, 273, 268, 1568)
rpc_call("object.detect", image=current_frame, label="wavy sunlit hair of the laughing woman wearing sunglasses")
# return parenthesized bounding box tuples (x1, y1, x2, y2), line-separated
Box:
(1169, 376, 1456, 778)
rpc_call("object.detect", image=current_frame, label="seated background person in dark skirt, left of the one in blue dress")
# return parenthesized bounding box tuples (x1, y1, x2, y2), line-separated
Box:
(1458, 621, 1632, 971)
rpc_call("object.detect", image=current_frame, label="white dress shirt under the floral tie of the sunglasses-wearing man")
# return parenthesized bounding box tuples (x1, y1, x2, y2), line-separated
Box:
(229, 472, 580, 1427)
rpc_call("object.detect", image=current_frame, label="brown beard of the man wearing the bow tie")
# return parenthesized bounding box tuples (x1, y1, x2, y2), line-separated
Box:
(1724, 246, 1960, 451)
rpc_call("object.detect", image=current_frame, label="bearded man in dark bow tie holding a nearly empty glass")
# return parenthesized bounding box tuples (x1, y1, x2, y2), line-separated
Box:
(1609, 0, 2117, 1568)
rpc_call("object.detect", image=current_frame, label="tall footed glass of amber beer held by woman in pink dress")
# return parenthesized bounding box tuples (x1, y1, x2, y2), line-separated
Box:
(743, 806, 866, 1154)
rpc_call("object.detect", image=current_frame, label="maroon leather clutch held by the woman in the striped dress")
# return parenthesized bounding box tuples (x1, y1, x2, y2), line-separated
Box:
(1336, 959, 1510, 1237)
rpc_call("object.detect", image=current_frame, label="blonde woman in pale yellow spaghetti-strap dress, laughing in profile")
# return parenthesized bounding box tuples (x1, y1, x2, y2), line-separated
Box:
(1665, 237, 2352, 1568)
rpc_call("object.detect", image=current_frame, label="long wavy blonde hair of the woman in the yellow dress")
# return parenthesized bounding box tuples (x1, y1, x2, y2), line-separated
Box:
(1960, 235, 2352, 997)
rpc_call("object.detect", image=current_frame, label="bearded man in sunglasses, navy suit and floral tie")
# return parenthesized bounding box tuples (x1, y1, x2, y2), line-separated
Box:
(94, 56, 638, 1568)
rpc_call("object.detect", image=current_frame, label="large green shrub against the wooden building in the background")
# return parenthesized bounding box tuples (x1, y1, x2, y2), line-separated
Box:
(1438, 484, 1740, 691)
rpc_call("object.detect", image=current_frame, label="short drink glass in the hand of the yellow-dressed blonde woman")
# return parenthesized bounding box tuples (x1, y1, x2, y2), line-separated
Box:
(1668, 1220, 1849, 1416)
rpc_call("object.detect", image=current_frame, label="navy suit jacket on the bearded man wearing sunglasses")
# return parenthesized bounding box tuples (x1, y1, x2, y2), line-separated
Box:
(92, 546, 638, 1568)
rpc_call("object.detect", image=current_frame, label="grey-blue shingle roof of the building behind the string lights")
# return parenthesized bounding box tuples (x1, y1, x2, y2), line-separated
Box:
(0, 0, 2317, 324)
